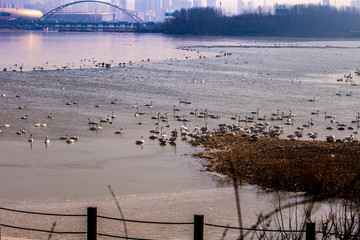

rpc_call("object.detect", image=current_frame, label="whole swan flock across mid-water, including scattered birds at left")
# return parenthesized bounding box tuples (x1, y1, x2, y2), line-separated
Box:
(0, 87, 360, 146)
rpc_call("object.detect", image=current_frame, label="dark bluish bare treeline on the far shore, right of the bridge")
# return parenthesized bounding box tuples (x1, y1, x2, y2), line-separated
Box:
(163, 5, 360, 37)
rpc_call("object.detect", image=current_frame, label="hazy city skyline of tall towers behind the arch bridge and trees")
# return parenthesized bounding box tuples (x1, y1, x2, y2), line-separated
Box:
(0, 0, 354, 21)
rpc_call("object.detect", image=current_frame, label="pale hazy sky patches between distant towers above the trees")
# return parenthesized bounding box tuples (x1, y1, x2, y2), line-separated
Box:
(128, 0, 351, 12)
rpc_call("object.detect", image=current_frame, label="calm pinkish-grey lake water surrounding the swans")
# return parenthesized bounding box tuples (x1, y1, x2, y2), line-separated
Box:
(0, 31, 360, 239)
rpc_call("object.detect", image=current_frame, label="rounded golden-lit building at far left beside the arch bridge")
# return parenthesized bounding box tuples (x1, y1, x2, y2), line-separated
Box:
(0, 8, 43, 20)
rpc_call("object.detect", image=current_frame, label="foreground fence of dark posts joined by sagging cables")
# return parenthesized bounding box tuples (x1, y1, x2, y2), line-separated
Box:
(0, 207, 319, 240)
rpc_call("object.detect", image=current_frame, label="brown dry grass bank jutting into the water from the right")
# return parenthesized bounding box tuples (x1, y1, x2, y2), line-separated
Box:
(196, 133, 360, 200)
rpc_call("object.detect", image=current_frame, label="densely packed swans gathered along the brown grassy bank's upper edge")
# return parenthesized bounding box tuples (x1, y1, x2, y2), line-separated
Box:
(136, 98, 360, 145)
